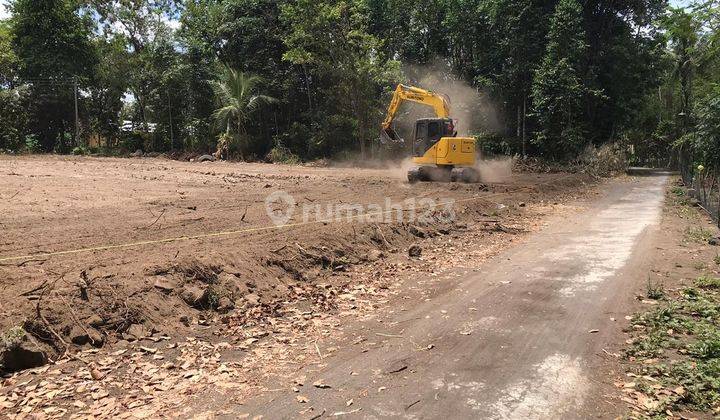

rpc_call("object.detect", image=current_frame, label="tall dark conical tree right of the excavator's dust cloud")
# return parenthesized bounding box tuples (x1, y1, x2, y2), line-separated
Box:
(532, 0, 591, 157)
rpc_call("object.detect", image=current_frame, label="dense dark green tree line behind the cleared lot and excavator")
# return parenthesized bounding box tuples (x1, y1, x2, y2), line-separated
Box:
(0, 0, 720, 164)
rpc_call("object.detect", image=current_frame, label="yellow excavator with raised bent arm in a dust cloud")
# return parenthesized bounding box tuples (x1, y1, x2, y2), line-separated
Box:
(380, 84, 480, 183)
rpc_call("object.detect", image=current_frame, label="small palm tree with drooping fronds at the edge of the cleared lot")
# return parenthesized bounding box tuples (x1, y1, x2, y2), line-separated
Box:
(213, 66, 277, 155)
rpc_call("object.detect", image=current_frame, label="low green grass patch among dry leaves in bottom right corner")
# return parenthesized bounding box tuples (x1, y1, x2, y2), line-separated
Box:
(625, 276, 720, 418)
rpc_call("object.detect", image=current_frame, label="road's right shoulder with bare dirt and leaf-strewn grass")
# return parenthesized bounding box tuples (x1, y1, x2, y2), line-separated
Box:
(603, 179, 720, 418)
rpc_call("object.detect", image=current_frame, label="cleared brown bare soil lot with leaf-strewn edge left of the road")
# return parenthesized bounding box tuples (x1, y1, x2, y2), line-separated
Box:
(0, 156, 592, 417)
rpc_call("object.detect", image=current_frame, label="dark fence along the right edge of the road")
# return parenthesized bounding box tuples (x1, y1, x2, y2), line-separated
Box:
(678, 147, 720, 227)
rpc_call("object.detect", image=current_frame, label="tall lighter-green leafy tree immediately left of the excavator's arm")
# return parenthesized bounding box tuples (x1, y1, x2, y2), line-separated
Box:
(282, 0, 398, 156)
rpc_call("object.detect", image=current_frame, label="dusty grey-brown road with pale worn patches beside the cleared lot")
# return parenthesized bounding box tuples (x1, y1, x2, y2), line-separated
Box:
(232, 173, 666, 419)
